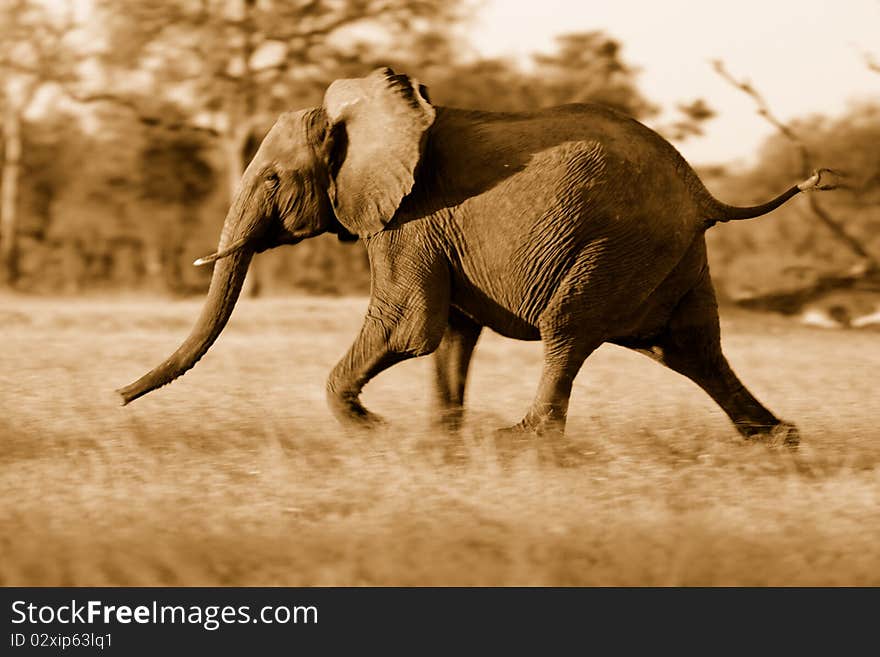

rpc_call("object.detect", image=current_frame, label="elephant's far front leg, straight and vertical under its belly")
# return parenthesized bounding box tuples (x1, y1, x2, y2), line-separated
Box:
(434, 308, 483, 433)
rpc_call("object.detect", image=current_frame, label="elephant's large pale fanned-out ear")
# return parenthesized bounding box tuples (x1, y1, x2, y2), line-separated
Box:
(324, 68, 435, 237)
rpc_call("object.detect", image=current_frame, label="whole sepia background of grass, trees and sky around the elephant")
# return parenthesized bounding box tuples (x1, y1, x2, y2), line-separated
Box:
(0, 0, 880, 585)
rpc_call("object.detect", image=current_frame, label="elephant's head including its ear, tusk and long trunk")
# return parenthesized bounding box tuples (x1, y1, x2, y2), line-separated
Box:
(118, 68, 434, 404)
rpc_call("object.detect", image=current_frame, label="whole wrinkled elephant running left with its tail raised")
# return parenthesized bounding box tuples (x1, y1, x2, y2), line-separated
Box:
(119, 68, 828, 444)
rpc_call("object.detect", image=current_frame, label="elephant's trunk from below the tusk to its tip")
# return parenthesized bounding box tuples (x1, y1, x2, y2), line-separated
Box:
(117, 247, 253, 406)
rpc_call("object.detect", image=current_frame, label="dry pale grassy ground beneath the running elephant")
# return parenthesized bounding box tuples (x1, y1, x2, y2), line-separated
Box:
(0, 297, 880, 585)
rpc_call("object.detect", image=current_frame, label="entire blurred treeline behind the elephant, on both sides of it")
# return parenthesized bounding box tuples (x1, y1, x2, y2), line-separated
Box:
(0, 0, 880, 296)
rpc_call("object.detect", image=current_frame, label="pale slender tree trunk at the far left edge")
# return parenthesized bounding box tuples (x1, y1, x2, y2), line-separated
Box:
(0, 100, 21, 287)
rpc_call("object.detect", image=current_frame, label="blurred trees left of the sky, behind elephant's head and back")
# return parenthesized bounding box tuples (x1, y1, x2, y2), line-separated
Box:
(0, 0, 710, 292)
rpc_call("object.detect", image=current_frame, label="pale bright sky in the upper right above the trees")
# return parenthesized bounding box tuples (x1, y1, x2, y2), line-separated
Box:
(468, 0, 880, 164)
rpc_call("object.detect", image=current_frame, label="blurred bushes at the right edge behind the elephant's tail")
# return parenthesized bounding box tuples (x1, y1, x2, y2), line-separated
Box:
(707, 97, 880, 312)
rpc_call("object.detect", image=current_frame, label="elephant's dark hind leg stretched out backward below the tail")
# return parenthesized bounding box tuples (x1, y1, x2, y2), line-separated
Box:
(638, 270, 799, 446)
